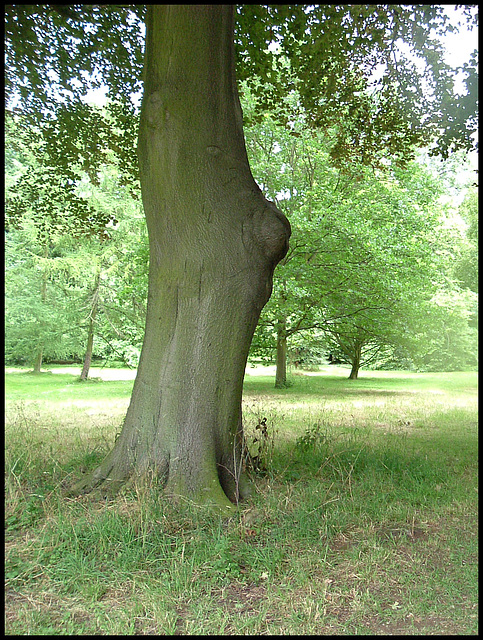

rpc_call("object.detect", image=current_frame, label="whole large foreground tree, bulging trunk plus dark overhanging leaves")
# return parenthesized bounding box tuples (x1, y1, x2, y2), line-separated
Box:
(6, 5, 480, 509)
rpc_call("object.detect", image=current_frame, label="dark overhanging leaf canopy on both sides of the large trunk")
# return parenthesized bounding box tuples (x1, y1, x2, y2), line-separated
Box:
(5, 5, 477, 172)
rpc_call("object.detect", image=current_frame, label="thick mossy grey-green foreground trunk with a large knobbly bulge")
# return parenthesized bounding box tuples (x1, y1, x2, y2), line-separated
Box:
(71, 5, 290, 511)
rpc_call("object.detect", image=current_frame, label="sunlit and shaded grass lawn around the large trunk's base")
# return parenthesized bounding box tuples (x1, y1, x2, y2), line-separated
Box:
(5, 367, 478, 635)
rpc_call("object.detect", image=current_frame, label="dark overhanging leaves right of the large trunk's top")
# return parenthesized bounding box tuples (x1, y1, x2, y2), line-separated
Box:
(238, 5, 477, 163)
